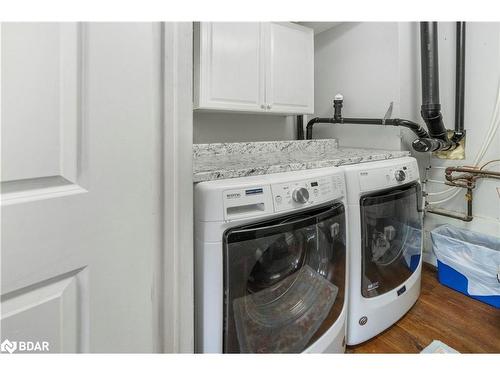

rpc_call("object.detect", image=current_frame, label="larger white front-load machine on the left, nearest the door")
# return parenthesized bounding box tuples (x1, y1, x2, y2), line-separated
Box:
(195, 168, 348, 353)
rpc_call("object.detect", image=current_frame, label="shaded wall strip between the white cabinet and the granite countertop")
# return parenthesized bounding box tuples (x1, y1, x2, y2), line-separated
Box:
(193, 111, 295, 143)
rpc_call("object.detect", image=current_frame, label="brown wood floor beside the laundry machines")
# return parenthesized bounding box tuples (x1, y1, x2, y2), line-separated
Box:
(347, 264, 500, 353)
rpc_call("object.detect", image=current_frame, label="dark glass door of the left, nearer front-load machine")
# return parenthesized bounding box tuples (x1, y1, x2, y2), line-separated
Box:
(224, 203, 346, 353)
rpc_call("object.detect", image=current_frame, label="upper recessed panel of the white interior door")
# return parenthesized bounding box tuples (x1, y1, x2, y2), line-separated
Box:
(1, 23, 81, 182)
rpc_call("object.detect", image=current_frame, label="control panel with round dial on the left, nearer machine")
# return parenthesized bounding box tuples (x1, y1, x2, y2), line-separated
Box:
(271, 175, 345, 212)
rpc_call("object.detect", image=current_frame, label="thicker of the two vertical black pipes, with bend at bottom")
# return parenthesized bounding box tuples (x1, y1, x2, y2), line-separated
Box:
(414, 22, 453, 151)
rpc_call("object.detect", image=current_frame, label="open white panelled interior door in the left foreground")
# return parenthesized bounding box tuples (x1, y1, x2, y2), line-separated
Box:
(0, 23, 167, 352)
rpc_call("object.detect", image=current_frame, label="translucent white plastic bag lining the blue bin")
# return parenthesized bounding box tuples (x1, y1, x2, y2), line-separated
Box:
(431, 224, 500, 296)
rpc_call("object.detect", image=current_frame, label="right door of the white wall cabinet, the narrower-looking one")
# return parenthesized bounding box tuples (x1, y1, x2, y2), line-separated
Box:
(264, 22, 314, 114)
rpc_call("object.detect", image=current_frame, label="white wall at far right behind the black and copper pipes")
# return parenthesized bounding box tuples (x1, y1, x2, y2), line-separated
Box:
(407, 22, 500, 262)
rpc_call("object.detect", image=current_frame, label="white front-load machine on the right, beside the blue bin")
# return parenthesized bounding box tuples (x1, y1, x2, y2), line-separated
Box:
(342, 157, 422, 345)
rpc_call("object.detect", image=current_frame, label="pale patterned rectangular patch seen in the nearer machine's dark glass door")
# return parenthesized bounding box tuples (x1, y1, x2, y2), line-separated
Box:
(233, 265, 338, 353)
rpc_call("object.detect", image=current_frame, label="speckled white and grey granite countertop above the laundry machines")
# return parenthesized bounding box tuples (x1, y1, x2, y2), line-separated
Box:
(193, 139, 410, 182)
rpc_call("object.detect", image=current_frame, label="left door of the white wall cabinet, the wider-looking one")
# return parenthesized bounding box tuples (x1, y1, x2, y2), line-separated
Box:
(195, 22, 265, 112)
